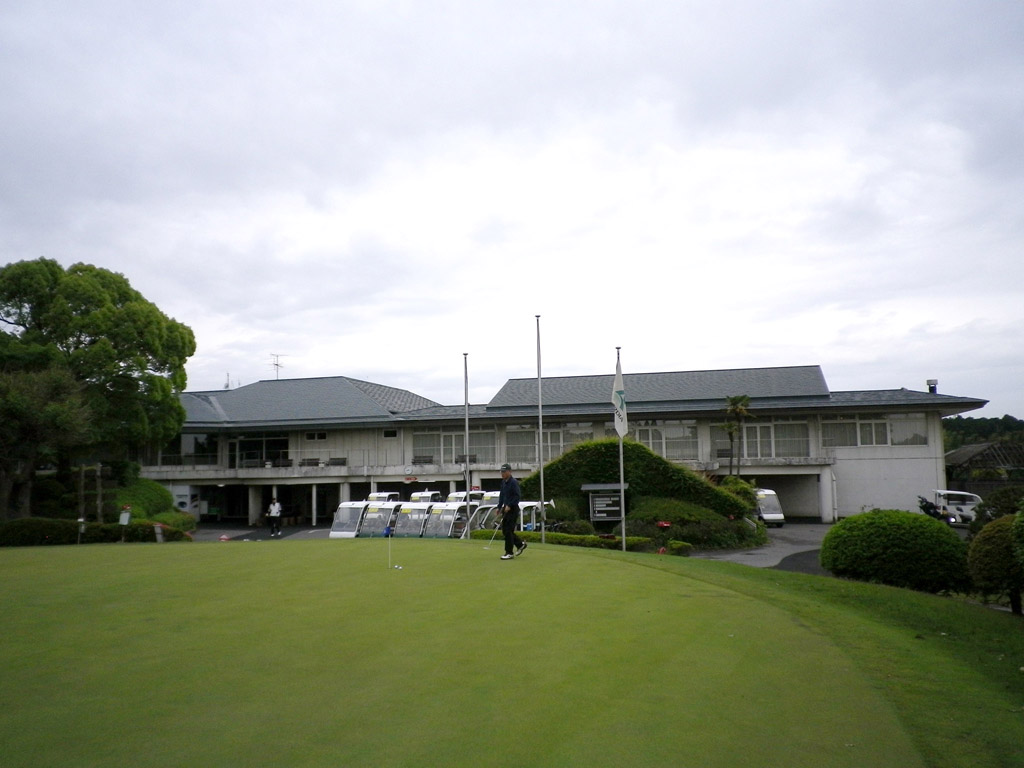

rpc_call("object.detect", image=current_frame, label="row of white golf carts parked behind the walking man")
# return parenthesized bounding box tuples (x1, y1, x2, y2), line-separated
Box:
(330, 490, 550, 539)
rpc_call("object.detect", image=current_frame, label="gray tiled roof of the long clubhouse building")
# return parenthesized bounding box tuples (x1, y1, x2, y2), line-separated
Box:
(181, 366, 986, 430)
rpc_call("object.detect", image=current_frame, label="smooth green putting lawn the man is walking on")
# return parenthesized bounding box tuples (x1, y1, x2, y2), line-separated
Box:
(0, 539, 1024, 768)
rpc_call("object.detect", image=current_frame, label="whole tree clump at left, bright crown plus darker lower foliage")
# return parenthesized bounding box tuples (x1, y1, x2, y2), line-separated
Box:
(0, 258, 196, 518)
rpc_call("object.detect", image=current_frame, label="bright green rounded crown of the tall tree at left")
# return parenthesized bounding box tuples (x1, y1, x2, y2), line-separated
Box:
(0, 258, 196, 451)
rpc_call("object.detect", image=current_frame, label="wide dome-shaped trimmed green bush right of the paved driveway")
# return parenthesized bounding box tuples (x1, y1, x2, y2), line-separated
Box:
(820, 509, 969, 593)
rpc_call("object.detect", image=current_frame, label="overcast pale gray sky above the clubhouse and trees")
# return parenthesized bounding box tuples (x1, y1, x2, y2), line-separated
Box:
(0, 0, 1024, 418)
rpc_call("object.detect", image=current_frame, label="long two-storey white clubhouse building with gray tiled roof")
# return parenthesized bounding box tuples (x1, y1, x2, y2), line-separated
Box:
(140, 366, 986, 525)
